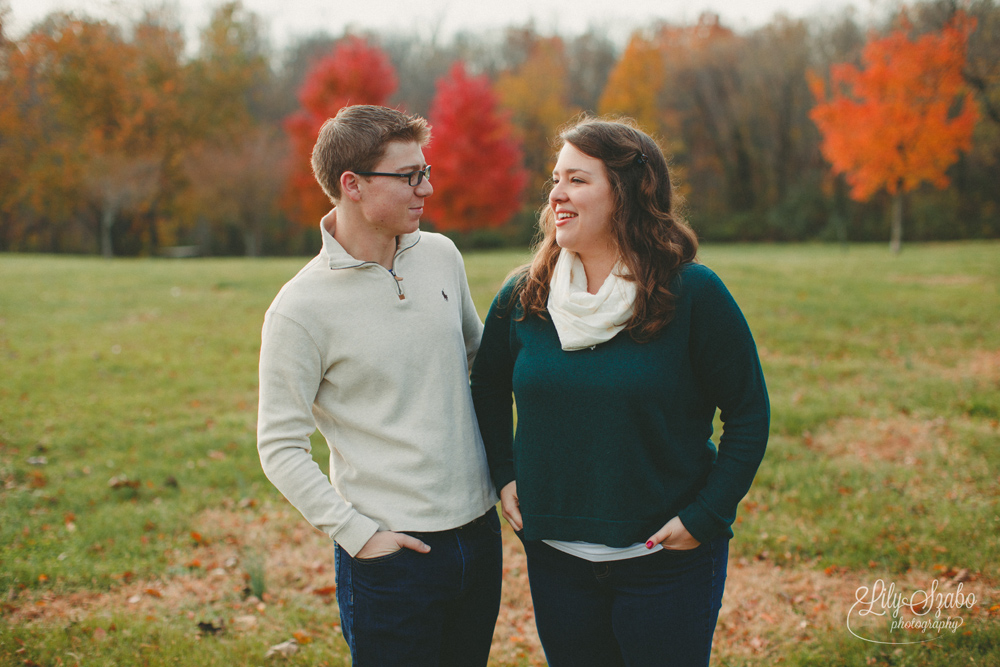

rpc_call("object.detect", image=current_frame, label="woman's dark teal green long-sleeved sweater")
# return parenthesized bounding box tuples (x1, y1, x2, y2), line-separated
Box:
(472, 264, 770, 547)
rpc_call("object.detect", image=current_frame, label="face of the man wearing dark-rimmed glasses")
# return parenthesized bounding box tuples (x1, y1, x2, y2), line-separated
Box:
(358, 141, 434, 236)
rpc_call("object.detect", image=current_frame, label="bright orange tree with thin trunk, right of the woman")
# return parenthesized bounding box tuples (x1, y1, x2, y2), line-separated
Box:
(810, 12, 978, 253)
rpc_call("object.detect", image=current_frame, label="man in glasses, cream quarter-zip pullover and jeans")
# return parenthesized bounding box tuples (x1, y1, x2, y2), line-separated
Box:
(257, 106, 501, 667)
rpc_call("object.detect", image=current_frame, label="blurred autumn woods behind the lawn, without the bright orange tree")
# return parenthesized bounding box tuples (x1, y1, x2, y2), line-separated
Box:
(0, 0, 1000, 256)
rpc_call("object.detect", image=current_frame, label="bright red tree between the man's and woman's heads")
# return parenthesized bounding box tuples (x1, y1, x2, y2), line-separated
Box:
(425, 62, 528, 232)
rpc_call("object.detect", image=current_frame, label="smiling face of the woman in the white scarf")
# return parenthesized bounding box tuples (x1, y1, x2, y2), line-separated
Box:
(549, 143, 615, 260)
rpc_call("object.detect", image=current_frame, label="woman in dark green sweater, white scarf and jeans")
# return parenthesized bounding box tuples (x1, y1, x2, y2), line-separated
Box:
(472, 119, 769, 667)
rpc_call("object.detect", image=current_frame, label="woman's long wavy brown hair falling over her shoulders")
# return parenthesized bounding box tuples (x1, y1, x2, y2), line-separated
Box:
(518, 117, 698, 342)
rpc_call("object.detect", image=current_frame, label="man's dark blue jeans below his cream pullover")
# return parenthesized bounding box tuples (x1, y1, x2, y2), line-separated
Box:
(335, 509, 503, 667)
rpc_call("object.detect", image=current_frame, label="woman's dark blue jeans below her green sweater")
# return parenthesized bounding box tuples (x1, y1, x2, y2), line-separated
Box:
(524, 538, 729, 667)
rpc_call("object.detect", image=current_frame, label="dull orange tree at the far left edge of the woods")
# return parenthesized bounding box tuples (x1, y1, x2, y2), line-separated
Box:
(0, 15, 164, 255)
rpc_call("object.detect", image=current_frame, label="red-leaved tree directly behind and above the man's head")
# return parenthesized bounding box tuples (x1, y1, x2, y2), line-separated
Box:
(283, 36, 398, 226)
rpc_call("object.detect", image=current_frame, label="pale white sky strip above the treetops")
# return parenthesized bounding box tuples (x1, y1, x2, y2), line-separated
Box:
(0, 0, 895, 48)
